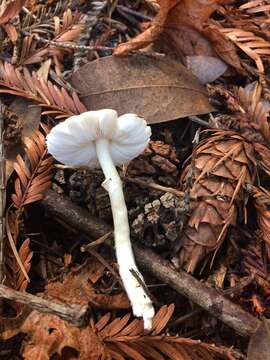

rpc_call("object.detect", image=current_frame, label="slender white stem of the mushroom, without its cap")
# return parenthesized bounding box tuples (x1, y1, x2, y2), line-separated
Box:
(96, 139, 154, 329)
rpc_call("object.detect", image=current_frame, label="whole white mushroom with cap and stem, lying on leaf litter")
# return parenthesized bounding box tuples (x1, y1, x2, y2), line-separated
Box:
(47, 109, 154, 329)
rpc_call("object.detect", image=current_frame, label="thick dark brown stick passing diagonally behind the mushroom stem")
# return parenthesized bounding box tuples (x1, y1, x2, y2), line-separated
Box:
(40, 190, 261, 336)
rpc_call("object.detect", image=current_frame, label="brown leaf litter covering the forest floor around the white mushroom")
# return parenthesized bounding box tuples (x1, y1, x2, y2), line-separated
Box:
(0, 0, 270, 360)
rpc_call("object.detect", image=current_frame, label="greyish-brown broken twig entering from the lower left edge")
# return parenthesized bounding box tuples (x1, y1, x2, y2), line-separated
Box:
(0, 284, 88, 326)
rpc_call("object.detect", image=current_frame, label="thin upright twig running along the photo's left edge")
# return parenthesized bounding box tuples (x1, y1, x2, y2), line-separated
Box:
(0, 103, 6, 284)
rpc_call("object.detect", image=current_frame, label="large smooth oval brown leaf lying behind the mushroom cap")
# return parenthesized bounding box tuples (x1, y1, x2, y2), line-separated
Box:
(71, 54, 213, 123)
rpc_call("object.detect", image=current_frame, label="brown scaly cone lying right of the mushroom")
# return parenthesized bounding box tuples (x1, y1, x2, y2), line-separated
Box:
(175, 130, 255, 272)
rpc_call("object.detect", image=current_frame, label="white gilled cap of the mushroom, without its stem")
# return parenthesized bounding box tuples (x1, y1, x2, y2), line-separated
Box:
(46, 109, 151, 168)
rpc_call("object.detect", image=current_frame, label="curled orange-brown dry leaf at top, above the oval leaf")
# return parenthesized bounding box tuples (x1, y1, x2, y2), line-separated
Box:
(114, 0, 241, 69)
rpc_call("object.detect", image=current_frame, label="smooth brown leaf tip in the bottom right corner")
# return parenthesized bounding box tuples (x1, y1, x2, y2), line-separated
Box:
(247, 319, 270, 360)
